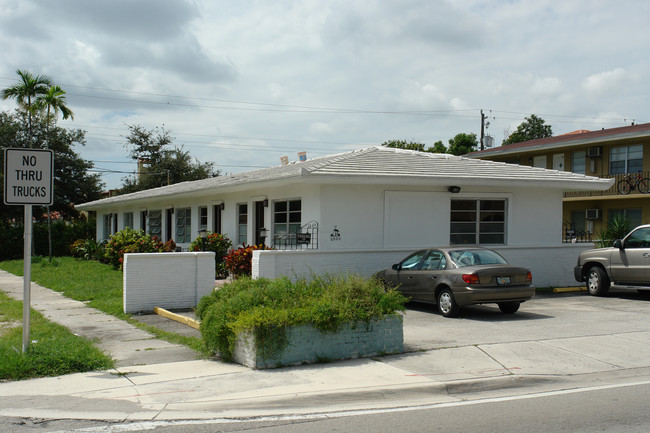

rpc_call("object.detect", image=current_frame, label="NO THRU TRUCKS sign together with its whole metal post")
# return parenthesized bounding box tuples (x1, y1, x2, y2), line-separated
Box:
(4, 148, 54, 353)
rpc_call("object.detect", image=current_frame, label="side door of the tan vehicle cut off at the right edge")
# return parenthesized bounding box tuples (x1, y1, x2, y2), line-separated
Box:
(611, 227, 650, 286)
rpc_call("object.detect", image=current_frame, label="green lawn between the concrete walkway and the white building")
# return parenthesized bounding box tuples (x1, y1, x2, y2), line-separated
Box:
(0, 257, 205, 368)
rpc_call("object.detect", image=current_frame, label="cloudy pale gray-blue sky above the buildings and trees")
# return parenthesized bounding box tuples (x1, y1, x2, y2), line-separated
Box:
(0, 0, 650, 187)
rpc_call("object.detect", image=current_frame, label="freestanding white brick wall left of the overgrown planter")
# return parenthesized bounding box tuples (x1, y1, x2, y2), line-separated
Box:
(124, 252, 215, 313)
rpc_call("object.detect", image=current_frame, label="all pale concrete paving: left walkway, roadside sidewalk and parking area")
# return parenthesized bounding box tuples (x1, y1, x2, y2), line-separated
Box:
(0, 271, 650, 421)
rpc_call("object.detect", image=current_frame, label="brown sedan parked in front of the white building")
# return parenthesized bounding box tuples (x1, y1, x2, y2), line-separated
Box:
(375, 247, 535, 317)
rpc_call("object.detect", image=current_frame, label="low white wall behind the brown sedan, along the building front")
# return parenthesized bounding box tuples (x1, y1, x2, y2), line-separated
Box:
(252, 244, 593, 287)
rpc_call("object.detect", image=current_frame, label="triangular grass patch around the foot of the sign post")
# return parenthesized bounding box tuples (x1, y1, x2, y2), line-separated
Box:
(0, 292, 113, 380)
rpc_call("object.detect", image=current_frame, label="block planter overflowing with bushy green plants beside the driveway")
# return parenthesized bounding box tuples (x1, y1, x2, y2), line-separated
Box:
(197, 276, 406, 368)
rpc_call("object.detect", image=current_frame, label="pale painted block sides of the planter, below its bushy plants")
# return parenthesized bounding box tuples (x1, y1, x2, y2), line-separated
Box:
(233, 315, 404, 369)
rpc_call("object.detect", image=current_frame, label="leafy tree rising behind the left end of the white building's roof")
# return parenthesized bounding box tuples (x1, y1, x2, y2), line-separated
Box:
(119, 125, 220, 194)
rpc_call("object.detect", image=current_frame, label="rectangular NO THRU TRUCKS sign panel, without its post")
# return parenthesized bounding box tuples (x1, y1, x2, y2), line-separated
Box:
(4, 148, 54, 206)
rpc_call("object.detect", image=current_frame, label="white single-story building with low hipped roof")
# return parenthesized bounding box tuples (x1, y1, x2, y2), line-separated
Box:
(77, 147, 611, 286)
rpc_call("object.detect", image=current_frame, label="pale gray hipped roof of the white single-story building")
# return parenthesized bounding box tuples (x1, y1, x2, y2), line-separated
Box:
(76, 146, 612, 210)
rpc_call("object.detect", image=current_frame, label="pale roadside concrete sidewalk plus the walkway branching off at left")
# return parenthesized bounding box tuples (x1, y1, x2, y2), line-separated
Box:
(0, 273, 650, 421)
